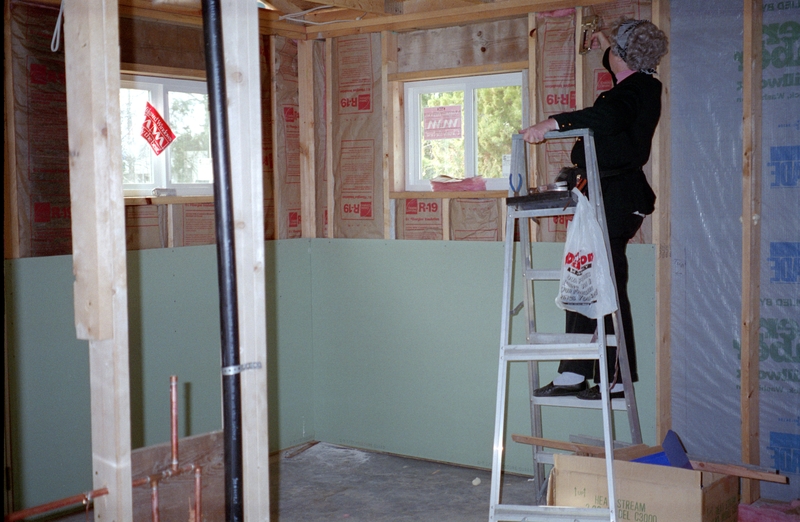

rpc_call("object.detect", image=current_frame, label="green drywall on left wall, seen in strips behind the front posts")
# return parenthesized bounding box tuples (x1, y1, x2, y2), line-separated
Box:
(4, 241, 314, 509)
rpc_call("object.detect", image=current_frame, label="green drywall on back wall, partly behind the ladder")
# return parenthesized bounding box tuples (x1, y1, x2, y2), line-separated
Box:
(312, 240, 655, 472)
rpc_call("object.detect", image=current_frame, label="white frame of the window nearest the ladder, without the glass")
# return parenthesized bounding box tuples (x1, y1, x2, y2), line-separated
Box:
(403, 70, 528, 192)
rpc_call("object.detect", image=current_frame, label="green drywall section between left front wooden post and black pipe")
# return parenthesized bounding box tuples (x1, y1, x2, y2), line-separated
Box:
(128, 246, 222, 448)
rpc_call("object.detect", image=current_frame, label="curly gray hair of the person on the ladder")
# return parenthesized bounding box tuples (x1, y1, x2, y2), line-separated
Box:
(611, 18, 669, 74)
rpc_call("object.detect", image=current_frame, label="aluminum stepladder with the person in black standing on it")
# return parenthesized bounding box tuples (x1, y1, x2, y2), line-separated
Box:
(489, 129, 642, 522)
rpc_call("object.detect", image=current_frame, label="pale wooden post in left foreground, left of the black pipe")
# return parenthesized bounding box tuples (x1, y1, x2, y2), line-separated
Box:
(64, 0, 133, 520)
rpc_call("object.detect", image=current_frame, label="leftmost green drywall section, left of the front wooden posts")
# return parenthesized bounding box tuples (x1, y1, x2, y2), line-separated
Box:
(3, 257, 92, 509)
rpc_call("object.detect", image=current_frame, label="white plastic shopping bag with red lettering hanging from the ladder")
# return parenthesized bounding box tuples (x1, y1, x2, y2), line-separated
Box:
(556, 189, 617, 319)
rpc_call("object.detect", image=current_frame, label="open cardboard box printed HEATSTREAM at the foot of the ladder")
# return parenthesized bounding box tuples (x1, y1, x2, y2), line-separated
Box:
(547, 454, 739, 522)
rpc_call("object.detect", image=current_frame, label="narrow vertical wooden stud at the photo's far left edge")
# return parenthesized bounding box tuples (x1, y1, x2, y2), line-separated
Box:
(3, 2, 19, 259)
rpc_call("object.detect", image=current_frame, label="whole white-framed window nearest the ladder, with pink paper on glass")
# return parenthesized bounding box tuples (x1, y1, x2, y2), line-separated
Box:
(404, 72, 526, 191)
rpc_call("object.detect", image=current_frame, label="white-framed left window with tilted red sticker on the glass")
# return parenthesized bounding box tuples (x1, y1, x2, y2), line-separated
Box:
(120, 76, 214, 196)
